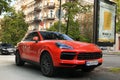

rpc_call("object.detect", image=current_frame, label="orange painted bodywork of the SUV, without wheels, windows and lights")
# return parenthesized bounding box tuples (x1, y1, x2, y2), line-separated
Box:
(18, 32, 103, 67)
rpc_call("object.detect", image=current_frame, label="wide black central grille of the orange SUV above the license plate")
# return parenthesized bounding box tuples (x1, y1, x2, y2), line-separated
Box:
(77, 53, 102, 60)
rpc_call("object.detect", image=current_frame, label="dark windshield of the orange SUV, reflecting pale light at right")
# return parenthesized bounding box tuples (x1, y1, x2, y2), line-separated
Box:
(40, 32, 73, 40)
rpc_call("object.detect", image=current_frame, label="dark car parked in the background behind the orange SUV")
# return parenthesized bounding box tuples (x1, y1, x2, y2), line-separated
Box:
(0, 43, 16, 55)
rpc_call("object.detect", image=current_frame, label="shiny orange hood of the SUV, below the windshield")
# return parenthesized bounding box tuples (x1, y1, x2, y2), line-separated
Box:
(55, 40, 101, 52)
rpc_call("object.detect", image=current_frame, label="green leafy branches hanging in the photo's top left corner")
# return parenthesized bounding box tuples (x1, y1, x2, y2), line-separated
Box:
(0, 0, 11, 15)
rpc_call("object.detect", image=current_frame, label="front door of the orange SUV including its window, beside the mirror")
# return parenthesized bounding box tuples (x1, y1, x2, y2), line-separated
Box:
(25, 32, 40, 62)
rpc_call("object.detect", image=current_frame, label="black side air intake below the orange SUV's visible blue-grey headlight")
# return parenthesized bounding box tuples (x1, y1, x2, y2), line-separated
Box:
(60, 52, 76, 60)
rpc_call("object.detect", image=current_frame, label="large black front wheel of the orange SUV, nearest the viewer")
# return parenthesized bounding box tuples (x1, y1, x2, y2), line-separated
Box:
(40, 52, 55, 77)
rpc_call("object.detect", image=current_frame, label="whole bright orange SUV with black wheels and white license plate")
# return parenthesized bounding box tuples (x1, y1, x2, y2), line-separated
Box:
(15, 31, 103, 76)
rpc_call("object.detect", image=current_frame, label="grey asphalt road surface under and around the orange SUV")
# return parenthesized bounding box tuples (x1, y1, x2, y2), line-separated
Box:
(0, 55, 120, 80)
